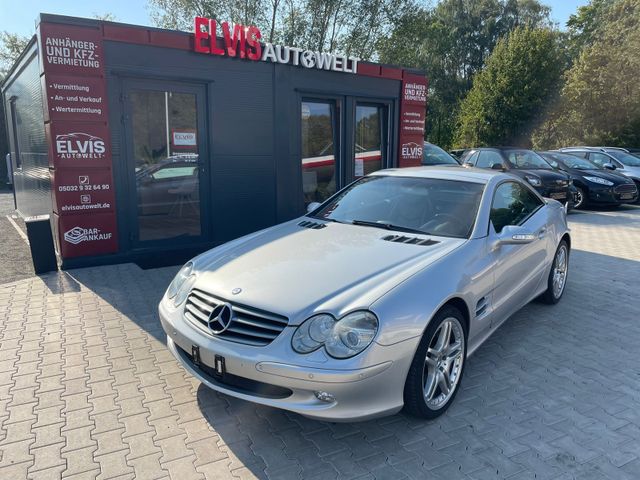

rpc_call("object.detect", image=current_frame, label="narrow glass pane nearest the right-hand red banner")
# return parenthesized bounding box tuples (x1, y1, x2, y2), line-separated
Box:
(354, 105, 384, 178)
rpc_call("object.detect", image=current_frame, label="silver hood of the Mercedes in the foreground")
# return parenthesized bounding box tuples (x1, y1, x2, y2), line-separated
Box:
(195, 218, 466, 325)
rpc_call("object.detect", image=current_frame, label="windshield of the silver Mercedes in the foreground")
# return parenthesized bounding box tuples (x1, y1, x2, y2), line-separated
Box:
(314, 175, 484, 238)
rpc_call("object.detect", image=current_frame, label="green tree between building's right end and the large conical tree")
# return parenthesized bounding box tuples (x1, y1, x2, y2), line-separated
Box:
(379, 0, 551, 148)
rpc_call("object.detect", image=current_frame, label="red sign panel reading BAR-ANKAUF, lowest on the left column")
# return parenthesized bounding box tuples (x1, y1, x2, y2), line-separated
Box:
(54, 213, 118, 258)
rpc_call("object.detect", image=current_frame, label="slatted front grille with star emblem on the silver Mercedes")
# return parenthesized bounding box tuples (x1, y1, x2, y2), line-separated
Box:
(184, 288, 289, 347)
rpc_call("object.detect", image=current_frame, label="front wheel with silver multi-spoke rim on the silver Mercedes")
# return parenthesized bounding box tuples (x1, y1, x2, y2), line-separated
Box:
(404, 305, 467, 419)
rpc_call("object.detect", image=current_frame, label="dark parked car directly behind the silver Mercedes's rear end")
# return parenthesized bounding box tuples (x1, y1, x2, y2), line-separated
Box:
(462, 147, 574, 210)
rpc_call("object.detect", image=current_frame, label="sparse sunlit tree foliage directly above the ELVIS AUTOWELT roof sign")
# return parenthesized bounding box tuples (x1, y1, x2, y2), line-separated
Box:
(149, 0, 413, 60)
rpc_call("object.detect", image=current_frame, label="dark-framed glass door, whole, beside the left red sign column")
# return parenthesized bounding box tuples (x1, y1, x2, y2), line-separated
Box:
(125, 81, 207, 245)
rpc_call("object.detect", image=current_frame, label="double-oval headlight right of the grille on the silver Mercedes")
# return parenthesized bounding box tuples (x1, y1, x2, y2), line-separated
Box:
(291, 310, 378, 358)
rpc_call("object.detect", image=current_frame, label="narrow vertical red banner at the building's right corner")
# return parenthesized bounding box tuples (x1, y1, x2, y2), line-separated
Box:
(398, 72, 427, 167)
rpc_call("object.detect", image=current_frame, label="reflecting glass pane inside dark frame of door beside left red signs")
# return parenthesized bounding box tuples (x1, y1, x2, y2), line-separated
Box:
(129, 90, 200, 241)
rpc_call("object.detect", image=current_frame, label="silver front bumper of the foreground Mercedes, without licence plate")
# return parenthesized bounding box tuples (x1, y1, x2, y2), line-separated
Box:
(159, 303, 420, 422)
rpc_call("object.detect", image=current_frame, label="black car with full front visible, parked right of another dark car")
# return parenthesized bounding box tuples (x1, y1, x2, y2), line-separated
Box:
(538, 151, 638, 208)
